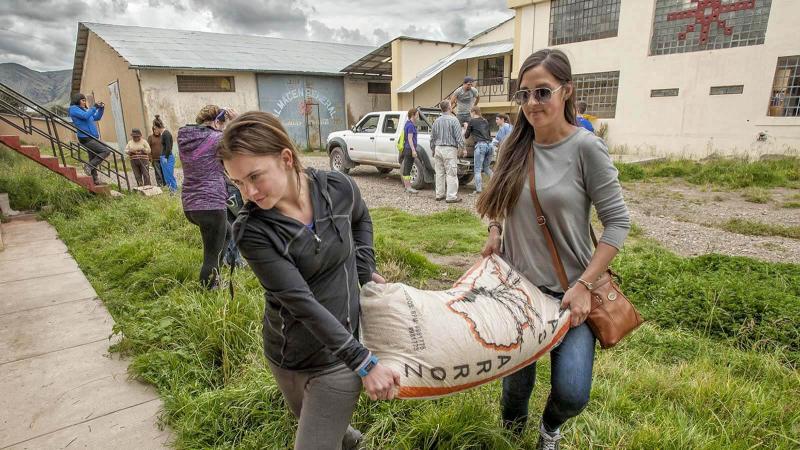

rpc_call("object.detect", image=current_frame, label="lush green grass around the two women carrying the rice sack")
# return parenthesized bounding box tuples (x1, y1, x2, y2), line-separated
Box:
(0, 149, 800, 449)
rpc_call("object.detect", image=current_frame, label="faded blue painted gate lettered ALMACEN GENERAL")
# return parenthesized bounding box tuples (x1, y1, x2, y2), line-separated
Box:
(258, 74, 346, 149)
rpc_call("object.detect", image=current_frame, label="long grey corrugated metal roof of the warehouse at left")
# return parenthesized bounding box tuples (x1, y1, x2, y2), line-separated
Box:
(82, 23, 375, 75)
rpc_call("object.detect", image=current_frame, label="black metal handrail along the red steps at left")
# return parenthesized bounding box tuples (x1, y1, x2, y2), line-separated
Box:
(0, 83, 131, 191)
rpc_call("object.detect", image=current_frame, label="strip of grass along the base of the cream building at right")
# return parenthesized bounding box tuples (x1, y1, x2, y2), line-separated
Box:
(617, 156, 800, 189)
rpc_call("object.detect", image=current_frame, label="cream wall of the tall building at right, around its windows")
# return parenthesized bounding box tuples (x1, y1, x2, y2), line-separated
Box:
(509, 0, 800, 157)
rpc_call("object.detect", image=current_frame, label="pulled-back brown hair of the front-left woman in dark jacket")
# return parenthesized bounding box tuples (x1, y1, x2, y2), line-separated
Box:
(217, 111, 303, 176)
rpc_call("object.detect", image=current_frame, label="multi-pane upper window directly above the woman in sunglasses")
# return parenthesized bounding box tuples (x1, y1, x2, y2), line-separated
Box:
(550, 0, 620, 45)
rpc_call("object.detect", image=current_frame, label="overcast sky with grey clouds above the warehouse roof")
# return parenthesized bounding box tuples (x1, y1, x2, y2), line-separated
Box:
(0, 0, 513, 71)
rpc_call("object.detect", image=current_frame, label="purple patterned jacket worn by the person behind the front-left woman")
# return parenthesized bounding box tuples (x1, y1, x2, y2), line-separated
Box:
(179, 125, 228, 211)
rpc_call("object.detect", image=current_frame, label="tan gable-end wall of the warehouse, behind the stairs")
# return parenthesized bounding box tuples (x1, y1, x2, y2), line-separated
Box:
(81, 31, 149, 148)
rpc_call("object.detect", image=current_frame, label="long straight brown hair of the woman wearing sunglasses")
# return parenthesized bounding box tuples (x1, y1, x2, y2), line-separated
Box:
(476, 49, 576, 220)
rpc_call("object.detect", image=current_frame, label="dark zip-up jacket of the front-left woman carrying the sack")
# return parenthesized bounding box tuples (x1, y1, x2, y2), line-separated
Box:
(234, 169, 375, 371)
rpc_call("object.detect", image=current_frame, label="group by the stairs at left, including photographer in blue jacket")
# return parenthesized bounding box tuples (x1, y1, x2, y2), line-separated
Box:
(69, 93, 178, 192)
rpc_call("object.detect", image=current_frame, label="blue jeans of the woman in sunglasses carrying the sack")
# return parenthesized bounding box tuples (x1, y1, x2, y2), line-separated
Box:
(500, 289, 595, 433)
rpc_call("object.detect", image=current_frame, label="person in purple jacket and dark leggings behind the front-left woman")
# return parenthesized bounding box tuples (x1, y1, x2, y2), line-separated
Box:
(178, 105, 236, 289)
